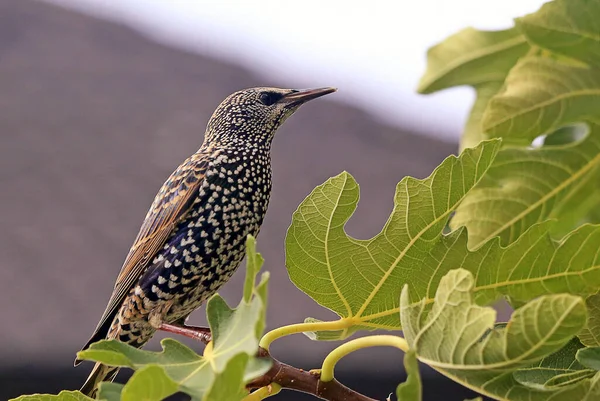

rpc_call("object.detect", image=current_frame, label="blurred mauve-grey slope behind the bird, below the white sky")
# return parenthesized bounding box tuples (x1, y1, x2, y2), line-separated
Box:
(0, 0, 466, 394)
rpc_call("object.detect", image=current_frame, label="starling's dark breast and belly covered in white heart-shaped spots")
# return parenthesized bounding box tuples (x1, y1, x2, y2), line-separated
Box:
(140, 148, 271, 317)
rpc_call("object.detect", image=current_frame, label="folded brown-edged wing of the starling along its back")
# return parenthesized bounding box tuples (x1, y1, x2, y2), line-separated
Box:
(84, 152, 209, 349)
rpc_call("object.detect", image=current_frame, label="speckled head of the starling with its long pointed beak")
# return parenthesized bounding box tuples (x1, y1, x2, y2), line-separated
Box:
(204, 88, 336, 145)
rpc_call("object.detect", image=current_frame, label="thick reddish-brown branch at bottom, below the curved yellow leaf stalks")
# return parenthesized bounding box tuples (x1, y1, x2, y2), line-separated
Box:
(246, 348, 377, 401)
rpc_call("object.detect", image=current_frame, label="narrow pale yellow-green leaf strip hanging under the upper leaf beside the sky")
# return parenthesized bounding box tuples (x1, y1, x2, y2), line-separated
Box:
(460, 81, 504, 151)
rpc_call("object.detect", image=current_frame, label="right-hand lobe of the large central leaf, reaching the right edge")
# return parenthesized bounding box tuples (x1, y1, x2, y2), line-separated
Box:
(420, 222, 600, 304)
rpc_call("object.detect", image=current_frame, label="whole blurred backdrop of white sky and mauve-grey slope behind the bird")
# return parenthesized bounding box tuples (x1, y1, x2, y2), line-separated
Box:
(0, 0, 542, 400)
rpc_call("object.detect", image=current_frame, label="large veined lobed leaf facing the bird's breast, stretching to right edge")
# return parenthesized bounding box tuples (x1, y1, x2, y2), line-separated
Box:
(287, 138, 600, 340)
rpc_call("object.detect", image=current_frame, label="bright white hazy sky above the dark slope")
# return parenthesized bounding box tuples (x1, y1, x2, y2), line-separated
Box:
(47, 0, 544, 138)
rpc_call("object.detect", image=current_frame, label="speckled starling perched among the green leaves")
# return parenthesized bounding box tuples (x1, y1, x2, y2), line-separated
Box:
(75, 87, 337, 397)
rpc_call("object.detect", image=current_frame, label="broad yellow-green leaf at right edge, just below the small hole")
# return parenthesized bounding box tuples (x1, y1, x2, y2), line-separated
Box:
(450, 122, 600, 247)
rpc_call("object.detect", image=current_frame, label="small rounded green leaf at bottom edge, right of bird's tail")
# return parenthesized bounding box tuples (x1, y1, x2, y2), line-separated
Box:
(121, 365, 179, 401)
